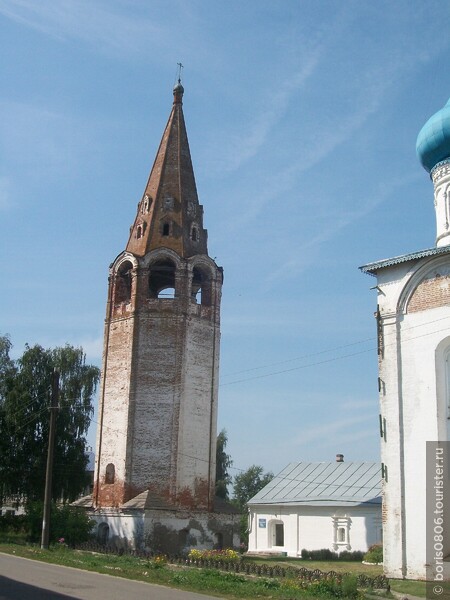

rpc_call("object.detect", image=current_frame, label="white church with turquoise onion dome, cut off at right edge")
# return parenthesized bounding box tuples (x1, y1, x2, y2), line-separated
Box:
(361, 101, 450, 580)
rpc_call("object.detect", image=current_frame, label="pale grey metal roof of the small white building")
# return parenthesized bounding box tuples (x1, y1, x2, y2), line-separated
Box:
(248, 462, 381, 506)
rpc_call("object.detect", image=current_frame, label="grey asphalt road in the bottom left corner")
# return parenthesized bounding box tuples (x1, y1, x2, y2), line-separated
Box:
(0, 553, 221, 600)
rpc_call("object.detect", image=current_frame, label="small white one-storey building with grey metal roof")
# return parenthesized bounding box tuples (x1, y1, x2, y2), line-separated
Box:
(248, 454, 382, 557)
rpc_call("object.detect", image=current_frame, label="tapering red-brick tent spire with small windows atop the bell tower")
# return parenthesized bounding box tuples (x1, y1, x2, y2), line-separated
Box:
(126, 80, 208, 258)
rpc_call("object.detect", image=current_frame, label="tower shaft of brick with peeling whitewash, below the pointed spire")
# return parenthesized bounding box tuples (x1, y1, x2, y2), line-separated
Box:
(94, 252, 222, 509)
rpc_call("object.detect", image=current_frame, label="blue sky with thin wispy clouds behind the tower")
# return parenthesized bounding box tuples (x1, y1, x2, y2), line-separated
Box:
(0, 0, 450, 474)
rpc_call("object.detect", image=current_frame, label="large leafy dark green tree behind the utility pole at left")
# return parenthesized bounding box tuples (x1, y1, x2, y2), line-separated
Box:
(0, 336, 99, 502)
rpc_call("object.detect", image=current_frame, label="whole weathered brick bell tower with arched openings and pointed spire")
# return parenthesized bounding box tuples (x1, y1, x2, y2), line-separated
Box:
(93, 80, 223, 511)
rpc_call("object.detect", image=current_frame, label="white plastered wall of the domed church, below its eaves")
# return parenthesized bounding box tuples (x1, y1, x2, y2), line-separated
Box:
(378, 257, 450, 579)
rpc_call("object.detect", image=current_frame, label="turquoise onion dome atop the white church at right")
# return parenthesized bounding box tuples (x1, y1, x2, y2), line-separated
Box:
(416, 100, 450, 172)
